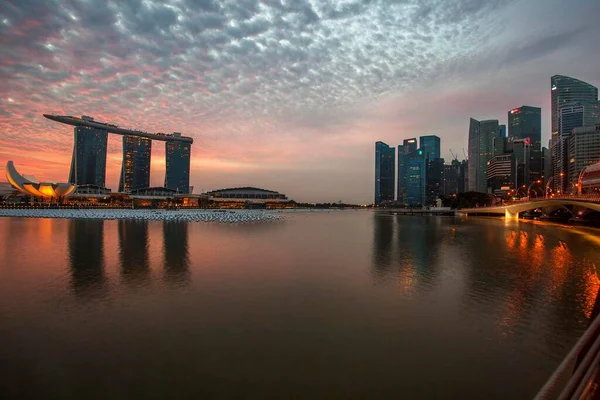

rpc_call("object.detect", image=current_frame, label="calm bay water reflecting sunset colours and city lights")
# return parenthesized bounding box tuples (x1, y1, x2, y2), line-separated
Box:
(0, 212, 600, 399)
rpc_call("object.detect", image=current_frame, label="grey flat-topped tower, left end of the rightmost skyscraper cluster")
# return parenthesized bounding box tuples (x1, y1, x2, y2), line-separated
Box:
(468, 118, 500, 193)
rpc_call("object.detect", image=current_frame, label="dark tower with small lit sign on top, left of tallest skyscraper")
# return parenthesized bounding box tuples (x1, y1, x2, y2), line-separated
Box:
(508, 106, 542, 185)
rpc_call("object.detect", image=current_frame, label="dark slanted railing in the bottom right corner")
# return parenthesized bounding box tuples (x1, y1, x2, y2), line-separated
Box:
(535, 314, 600, 400)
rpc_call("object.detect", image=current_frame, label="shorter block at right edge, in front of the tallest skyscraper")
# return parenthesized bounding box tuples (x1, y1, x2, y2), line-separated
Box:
(567, 124, 600, 193)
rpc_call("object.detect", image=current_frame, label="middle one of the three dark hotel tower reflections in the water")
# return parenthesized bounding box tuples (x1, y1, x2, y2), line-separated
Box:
(119, 220, 150, 286)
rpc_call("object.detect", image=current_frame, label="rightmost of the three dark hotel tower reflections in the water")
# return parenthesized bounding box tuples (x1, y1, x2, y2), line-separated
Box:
(163, 221, 190, 286)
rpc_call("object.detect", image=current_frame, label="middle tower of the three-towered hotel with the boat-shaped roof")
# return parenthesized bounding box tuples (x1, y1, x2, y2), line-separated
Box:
(119, 135, 152, 192)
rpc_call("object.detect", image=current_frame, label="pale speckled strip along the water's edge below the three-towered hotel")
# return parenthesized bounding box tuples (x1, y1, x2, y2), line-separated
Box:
(0, 208, 282, 224)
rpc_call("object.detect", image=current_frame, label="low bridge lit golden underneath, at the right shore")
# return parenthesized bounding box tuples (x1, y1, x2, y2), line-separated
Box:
(457, 195, 600, 219)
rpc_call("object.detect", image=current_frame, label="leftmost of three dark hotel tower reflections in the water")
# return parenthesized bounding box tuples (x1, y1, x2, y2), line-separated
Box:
(68, 219, 107, 298)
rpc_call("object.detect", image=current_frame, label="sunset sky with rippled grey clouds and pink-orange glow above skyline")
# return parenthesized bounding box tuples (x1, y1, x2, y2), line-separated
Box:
(0, 0, 600, 204)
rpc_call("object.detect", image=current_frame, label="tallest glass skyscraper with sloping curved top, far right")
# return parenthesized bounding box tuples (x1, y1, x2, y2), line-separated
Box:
(548, 75, 598, 192)
